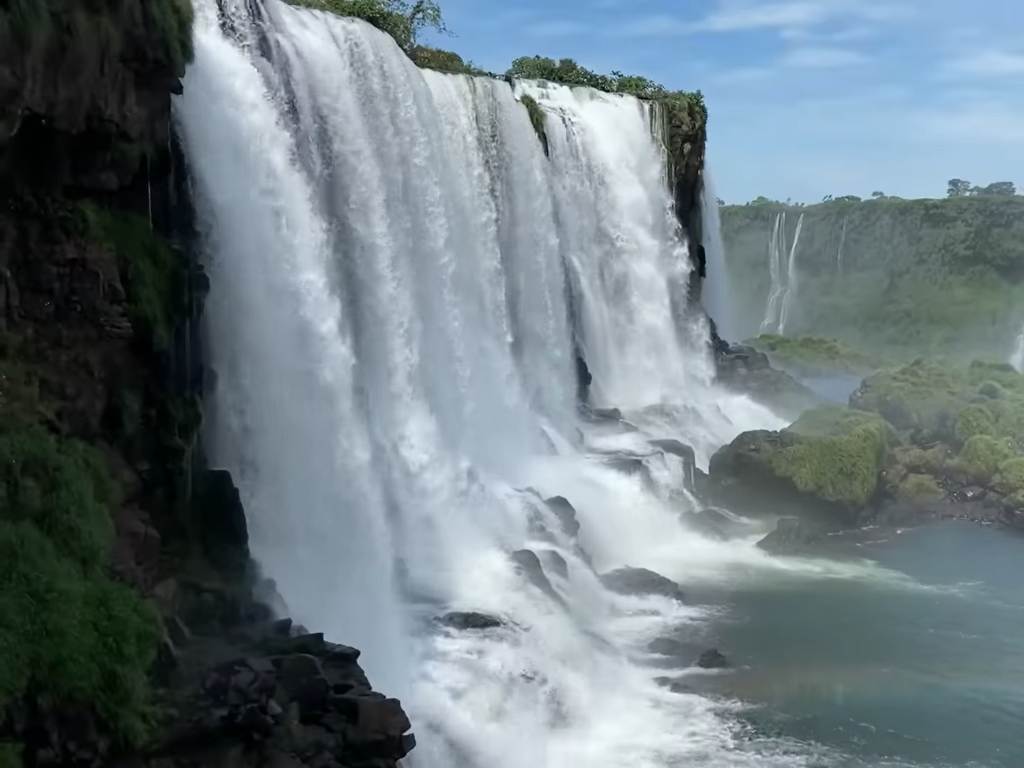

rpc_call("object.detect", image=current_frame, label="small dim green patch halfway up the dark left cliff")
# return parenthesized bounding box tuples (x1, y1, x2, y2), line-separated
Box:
(82, 205, 185, 350)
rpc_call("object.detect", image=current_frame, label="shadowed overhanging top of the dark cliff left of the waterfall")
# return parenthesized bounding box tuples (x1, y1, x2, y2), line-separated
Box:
(0, 0, 191, 191)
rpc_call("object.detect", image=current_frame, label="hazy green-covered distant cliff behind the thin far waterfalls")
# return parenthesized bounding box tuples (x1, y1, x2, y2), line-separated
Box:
(722, 197, 1024, 360)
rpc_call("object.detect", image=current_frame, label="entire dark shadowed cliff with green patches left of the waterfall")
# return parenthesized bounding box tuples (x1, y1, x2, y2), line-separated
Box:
(0, 0, 414, 768)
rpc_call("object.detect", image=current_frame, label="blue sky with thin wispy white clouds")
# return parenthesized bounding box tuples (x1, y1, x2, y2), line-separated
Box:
(421, 0, 1024, 202)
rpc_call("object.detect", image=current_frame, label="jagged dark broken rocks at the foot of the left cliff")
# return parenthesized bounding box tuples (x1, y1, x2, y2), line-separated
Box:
(114, 618, 416, 768)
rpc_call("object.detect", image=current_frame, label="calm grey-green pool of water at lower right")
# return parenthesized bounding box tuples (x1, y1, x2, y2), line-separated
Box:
(700, 522, 1024, 768)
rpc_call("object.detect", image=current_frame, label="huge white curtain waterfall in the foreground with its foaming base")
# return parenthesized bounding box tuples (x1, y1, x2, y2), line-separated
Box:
(175, 0, 792, 768)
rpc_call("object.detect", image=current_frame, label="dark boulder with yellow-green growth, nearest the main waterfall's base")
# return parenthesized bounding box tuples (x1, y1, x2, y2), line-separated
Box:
(711, 407, 890, 516)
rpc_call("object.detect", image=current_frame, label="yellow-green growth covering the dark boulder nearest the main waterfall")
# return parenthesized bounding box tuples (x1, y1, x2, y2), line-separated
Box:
(768, 407, 888, 506)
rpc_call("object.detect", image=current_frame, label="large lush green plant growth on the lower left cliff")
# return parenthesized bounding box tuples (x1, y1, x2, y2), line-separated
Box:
(0, 419, 157, 743)
